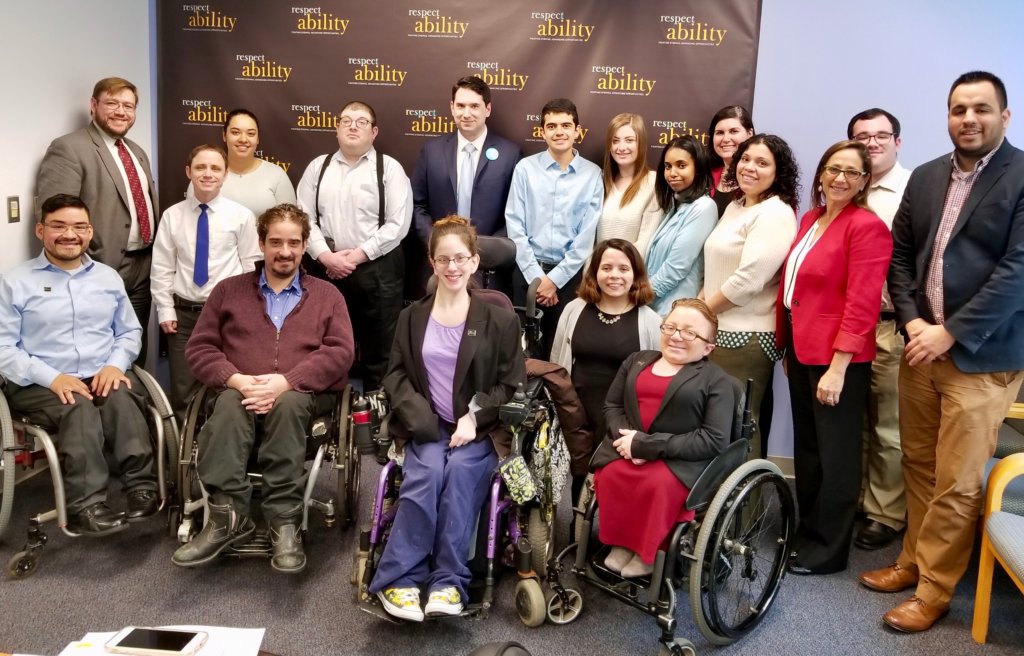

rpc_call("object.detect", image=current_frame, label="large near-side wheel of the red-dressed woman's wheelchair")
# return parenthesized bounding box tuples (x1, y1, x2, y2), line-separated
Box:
(690, 460, 795, 645)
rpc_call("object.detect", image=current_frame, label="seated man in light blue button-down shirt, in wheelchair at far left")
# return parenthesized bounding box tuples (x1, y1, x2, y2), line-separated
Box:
(0, 193, 158, 535)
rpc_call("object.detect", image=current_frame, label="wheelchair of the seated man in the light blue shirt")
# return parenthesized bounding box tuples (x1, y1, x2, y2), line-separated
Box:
(0, 365, 178, 579)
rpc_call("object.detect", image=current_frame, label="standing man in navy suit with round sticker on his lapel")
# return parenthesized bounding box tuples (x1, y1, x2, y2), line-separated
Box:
(406, 76, 522, 298)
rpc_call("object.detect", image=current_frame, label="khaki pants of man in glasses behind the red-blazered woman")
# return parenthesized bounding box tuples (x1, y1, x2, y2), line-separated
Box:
(861, 320, 906, 531)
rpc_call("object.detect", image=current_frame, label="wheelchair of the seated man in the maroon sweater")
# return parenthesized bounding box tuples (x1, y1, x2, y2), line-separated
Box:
(168, 385, 388, 558)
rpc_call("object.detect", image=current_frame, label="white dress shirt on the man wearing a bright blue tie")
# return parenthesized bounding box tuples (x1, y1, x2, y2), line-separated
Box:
(150, 194, 263, 323)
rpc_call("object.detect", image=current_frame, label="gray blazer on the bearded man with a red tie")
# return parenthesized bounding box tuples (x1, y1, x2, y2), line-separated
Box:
(36, 122, 160, 269)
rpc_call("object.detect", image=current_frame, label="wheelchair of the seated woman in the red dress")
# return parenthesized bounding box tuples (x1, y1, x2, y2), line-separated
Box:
(546, 381, 796, 656)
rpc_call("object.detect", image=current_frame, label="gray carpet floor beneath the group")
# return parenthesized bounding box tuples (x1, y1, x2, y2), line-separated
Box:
(0, 460, 1024, 656)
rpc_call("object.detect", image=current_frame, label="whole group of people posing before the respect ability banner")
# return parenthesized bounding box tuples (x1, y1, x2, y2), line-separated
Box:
(0, 72, 1024, 631)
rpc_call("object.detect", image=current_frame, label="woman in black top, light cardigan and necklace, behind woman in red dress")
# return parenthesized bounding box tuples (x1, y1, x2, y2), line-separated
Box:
(551, 238, 662, 504)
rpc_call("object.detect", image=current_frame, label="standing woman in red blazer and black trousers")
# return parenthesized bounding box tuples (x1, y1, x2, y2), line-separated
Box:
(776, 141, 893, 574)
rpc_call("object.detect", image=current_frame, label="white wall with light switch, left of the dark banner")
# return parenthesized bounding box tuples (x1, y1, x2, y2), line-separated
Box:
(0, 0, 156, 272)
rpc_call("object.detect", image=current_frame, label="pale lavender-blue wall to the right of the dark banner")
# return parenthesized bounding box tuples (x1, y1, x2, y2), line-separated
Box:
(754, 0, 1024, 207)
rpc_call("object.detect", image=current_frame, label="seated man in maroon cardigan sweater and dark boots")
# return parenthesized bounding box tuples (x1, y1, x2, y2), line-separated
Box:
(171, 205, 353, 573)
